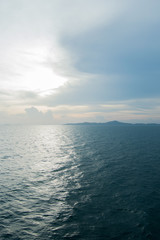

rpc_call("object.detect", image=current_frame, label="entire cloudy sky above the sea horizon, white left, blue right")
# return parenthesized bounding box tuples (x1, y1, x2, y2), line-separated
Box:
(0, 0, 160, 124)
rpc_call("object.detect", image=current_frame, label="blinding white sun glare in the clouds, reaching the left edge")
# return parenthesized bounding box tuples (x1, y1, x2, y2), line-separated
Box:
(0, 42, 68, 95)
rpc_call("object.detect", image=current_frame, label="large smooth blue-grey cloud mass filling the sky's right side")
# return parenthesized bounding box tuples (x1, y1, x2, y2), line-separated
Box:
(46, 1, 160, 110)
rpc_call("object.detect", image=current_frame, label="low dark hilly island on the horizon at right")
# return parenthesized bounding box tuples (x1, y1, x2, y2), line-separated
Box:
(64, 120, 160, 126)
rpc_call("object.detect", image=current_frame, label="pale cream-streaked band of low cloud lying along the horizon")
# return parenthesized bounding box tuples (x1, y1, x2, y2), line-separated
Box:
(0, 99, 160, 124)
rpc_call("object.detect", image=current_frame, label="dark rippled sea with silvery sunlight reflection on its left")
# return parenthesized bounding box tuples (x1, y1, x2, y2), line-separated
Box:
(0, 125, 160, 240)
